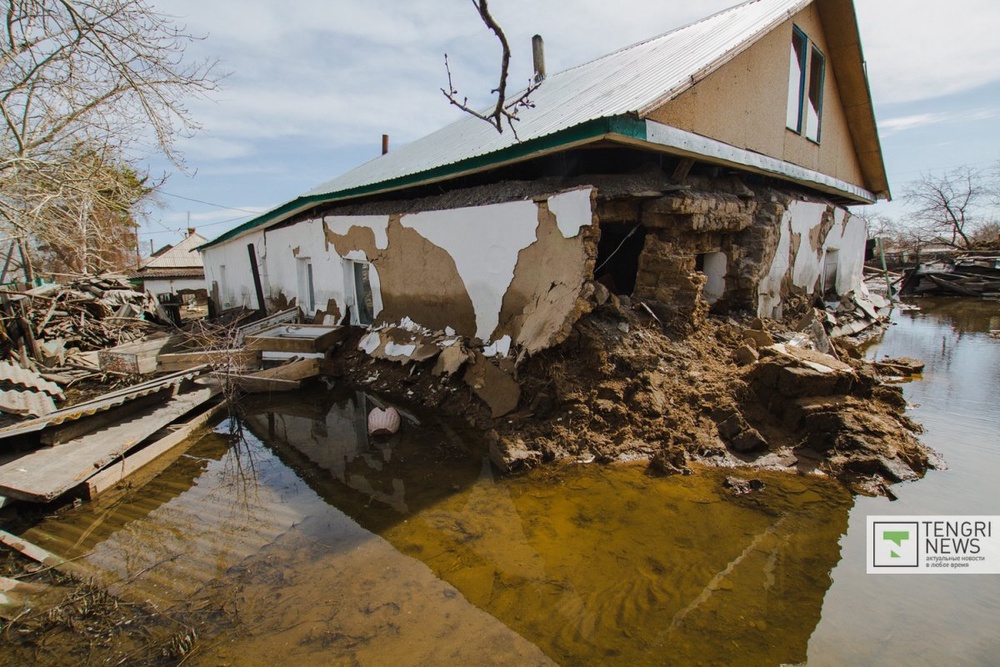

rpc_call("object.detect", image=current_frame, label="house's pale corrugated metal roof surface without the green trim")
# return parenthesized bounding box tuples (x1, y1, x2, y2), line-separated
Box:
(304, 0, 810, 197)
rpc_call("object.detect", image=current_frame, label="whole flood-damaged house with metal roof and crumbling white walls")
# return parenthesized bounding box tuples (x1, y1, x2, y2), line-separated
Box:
(202, 0, 889, 353)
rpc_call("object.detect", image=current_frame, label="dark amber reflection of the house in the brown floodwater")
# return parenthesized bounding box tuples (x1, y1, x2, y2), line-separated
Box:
(240, 394, 851, 664)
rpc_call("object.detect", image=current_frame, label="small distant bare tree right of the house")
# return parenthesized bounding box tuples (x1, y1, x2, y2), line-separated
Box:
(903, 166, 995, 249)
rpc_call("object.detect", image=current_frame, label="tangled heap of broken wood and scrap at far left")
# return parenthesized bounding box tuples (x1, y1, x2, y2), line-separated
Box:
(0, 275, 166, 416)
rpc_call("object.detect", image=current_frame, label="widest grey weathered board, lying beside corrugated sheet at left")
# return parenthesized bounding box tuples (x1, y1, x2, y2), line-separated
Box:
(0, 387, 218, 502)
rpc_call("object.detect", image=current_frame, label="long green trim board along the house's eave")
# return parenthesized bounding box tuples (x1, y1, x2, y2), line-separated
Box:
(198, 116, 646, 250)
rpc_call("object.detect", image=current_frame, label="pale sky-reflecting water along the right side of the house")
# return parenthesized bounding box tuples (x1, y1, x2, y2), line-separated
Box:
(809, 298, 1000, 665)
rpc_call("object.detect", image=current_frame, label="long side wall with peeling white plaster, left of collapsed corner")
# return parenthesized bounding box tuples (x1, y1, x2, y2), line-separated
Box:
(205, 187, 596, 351)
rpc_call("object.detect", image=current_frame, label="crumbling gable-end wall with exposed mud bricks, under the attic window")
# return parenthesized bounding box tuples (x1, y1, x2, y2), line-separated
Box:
(598, 179, 867, 331)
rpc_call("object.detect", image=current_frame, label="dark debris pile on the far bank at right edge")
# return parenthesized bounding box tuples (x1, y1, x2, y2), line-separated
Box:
(900, 250, 1000, 298)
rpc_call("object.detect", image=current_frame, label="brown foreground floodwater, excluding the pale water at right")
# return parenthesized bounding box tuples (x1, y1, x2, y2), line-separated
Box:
(19, 392, 853, 665)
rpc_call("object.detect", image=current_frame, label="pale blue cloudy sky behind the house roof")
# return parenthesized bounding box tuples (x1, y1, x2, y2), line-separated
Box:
(141, 0, 1000, 252)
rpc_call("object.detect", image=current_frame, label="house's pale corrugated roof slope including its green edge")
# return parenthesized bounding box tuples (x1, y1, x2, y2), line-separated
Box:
(201, 0, 813, 249)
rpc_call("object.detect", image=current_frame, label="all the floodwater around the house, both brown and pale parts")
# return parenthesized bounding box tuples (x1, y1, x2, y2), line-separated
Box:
(9, 300, 1000, 665)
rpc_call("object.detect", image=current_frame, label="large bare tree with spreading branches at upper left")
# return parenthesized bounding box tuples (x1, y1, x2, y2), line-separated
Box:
(0, 0, 219, 270)
